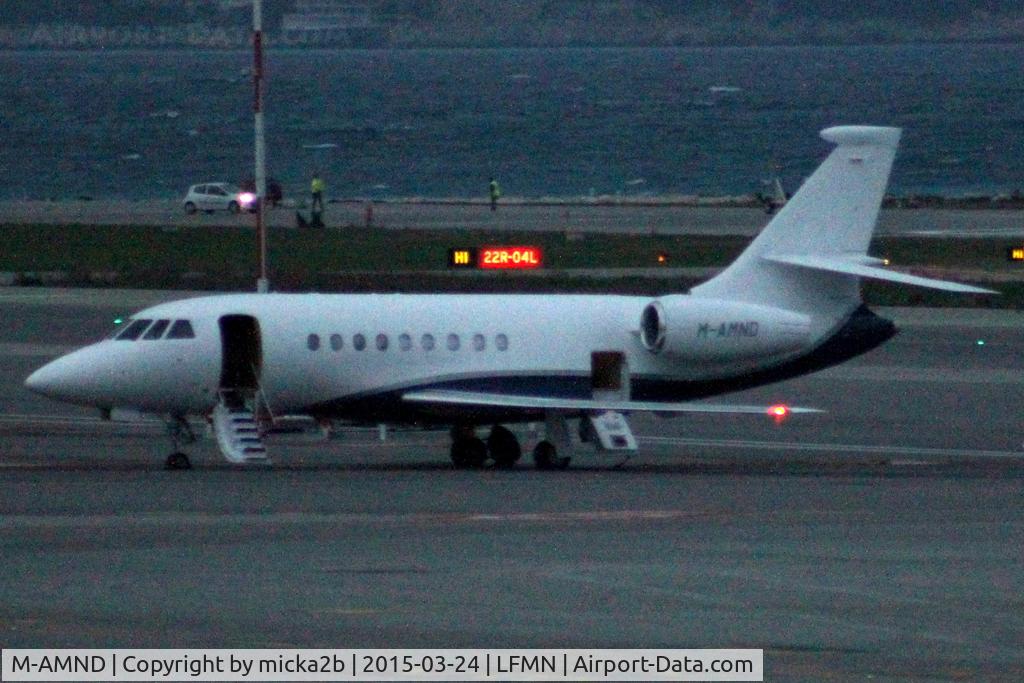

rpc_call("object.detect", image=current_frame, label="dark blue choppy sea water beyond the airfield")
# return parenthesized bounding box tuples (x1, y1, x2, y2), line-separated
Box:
(0, 45, 1024, 199)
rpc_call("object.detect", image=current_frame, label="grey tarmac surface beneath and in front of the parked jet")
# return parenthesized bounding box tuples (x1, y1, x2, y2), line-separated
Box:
(0, 290, 1024, 680)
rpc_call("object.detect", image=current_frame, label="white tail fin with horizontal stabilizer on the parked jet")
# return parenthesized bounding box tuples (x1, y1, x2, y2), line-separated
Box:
(691, 126, 988, 319)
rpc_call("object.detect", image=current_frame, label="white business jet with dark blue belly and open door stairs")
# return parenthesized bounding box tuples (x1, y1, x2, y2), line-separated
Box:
(26, 126, 989, 468)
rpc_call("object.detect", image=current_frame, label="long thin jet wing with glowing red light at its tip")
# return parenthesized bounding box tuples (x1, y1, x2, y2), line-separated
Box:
(402, 389, 824, 418)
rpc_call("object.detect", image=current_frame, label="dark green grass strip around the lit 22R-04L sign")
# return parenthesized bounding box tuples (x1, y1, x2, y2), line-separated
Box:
(0, 224, 1024, 308)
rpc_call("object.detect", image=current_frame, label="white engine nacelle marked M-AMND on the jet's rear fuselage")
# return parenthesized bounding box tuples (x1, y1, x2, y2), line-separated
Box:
(640, 295, 811, 362)
